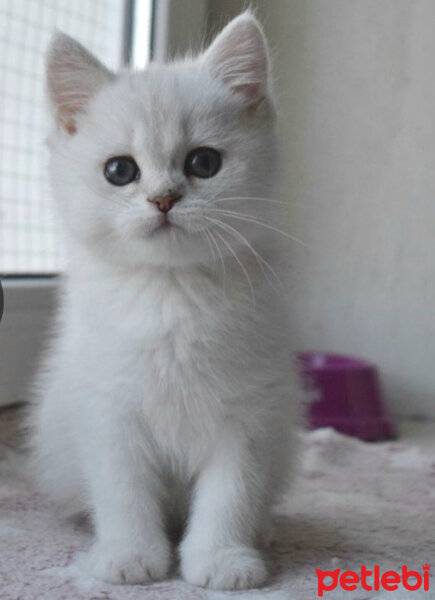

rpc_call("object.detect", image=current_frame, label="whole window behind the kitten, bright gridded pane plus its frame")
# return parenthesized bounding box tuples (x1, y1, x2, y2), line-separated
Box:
(0, 0, 206, 407)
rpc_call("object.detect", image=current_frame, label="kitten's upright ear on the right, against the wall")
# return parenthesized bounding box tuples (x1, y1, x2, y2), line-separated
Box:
(203, 11, 269, 110)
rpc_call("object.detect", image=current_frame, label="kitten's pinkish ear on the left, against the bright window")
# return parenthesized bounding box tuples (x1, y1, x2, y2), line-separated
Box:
(47, 33, 114, 134)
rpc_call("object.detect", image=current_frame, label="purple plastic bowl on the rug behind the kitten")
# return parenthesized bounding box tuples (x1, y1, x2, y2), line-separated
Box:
(297, 352, 396, 441)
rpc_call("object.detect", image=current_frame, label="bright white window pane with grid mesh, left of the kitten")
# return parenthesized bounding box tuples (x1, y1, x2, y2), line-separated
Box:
(0, 0, 125, 274)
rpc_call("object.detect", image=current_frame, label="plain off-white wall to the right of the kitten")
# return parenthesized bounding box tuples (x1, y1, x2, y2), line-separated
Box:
(207, 0, 435, 416)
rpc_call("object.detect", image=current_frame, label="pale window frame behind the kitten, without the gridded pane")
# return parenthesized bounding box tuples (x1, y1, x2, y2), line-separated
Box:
(0, 0, 207, 407)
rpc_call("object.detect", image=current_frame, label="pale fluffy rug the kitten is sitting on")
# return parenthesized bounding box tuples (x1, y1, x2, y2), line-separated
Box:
(0, 411, 435, 600)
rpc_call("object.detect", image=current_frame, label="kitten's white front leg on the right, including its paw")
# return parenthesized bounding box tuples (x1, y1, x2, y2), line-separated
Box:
(180, 430, 270, 590)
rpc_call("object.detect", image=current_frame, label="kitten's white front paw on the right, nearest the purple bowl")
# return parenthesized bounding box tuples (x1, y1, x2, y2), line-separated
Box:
(181, 546, 267, 590)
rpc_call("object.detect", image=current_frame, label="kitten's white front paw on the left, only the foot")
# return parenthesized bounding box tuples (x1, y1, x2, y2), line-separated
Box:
(84, 541, 170, 583)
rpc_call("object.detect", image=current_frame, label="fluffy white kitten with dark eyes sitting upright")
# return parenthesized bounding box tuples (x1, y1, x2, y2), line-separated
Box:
(32, 12, 300, 589)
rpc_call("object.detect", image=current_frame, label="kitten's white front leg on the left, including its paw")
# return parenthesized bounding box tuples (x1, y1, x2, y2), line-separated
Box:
(85, 414, 170, 583)
